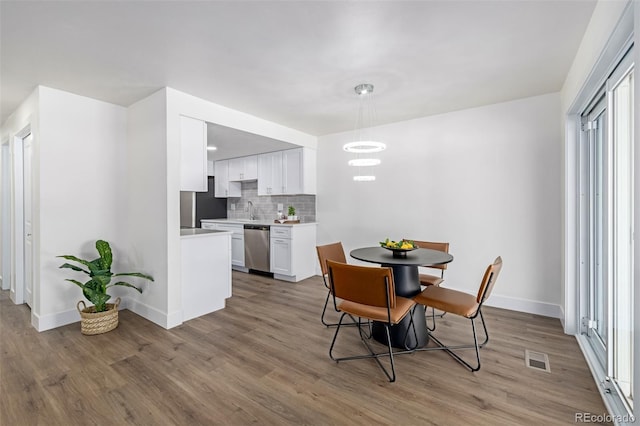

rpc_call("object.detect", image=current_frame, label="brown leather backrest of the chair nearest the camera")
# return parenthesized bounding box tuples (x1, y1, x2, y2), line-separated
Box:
(327, 260, 396, 309)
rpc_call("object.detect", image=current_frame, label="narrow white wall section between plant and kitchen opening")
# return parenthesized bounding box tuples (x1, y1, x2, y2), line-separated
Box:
(121, 89, 170, 328)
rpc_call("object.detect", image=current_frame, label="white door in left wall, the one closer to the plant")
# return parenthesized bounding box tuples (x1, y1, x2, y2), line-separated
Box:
(23, 135, 33, 306)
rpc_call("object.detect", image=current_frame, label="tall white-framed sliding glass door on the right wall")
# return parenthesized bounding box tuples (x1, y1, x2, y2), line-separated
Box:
(580, 49, 634, 411)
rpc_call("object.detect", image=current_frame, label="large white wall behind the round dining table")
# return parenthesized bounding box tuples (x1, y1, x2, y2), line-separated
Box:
(317, 94, 562, 316)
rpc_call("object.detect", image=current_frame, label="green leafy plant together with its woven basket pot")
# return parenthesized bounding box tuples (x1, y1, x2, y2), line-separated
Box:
(57, 240, 153, 334)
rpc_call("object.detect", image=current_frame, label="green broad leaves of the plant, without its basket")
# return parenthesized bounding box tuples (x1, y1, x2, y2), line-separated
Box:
(57, 240, 153, 312)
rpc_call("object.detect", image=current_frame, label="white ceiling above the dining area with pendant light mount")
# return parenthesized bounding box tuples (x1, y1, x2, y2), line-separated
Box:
(0, 0, 595, 140)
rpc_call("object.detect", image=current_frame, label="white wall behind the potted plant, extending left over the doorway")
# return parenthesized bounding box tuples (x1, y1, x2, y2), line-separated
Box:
(3, 86, 126, 331)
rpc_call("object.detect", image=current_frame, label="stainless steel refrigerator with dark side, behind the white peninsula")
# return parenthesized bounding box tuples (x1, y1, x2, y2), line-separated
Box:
(180, 176, 227, 228)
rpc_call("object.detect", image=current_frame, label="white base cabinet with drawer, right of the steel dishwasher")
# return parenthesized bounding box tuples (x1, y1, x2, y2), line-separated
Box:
(270, 224, 317, 282)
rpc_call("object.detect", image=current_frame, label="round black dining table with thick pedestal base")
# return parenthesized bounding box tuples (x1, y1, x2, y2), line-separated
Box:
(349, 247, 453, 349)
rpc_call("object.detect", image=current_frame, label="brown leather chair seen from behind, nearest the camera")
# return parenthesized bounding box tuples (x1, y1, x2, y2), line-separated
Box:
(327, 260, 416, 382)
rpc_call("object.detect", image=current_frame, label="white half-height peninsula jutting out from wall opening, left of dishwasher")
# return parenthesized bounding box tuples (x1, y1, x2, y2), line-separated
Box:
(180, 228, 232, 321)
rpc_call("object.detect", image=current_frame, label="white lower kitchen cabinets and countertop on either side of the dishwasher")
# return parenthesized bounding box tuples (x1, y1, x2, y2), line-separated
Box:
(201, 219, 317, 282)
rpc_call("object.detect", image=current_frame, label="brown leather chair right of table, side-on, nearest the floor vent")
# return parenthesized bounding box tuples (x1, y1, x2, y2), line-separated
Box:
(413, 256, 502, 371)
